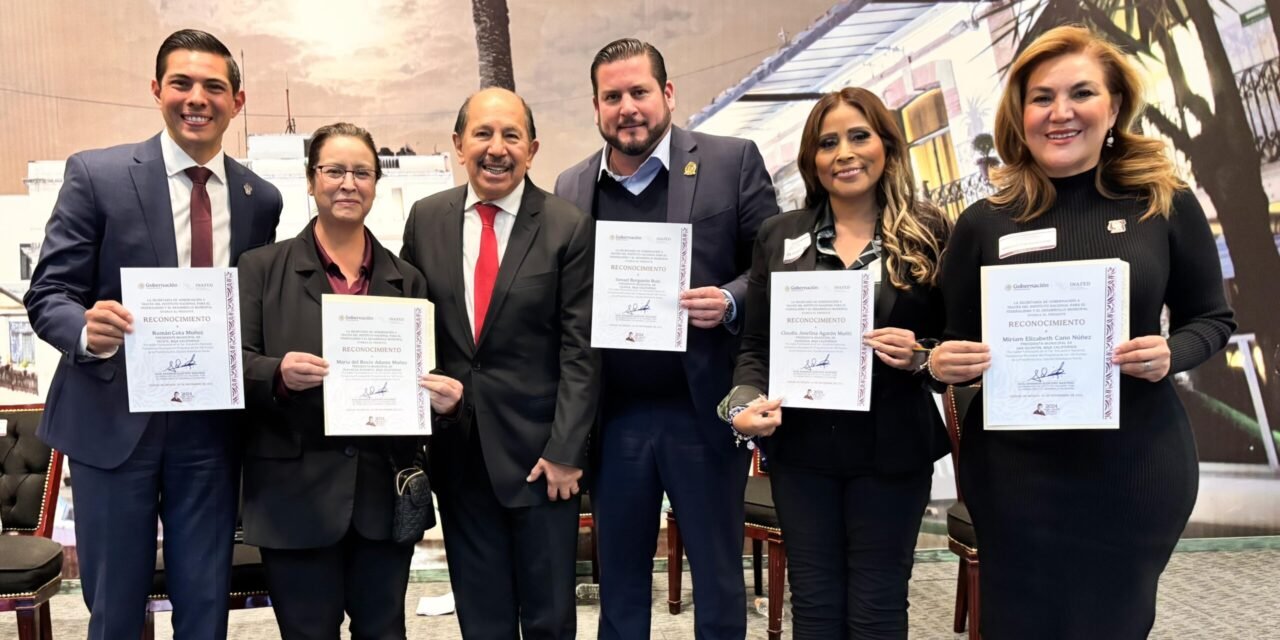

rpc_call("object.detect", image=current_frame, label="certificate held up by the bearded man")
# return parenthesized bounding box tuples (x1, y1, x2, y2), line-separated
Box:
(591, 221, 694, 351)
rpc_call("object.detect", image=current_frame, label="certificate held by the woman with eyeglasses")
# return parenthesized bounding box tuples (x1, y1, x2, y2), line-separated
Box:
(320, 293, 435, 435)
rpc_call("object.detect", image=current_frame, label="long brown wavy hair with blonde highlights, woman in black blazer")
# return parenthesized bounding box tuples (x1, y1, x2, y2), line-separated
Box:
(796, 87, 951, 289)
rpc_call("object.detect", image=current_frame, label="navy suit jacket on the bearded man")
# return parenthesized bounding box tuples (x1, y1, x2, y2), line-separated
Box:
(556, 127, 778, 442)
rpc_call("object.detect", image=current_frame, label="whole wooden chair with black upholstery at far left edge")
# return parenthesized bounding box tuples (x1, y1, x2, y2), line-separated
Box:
(0, 404, 63, 640)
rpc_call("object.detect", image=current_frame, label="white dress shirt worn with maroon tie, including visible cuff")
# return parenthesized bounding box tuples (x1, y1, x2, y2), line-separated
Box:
(78, 129, 232, 358)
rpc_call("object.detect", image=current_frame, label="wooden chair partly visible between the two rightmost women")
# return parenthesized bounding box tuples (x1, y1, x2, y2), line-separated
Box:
(942, 385, 982, 640)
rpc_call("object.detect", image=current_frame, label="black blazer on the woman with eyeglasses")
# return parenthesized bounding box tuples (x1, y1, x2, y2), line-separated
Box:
(239, 220, 426, 549)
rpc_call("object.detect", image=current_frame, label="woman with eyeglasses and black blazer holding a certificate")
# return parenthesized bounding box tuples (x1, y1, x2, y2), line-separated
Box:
(238, 123, 462, 640)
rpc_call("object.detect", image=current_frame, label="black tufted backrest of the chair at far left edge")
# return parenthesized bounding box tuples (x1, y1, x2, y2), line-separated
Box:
(0, 404, 63, 538)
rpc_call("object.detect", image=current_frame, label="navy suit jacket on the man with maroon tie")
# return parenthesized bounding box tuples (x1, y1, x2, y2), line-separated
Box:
(23, 136, 283, 468)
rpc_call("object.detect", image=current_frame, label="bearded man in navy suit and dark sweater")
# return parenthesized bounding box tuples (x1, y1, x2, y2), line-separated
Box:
(556, 38, 778, 639)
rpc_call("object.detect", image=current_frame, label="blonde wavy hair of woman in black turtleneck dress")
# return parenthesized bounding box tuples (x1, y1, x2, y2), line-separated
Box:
(987, 26, 1187, 221)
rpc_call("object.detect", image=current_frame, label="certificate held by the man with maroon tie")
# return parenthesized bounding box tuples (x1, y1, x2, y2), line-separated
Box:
(120, 268, 244, 413)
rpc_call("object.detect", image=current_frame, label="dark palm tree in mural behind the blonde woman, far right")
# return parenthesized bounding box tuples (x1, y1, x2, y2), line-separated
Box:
(987, 0, 1280, 430)
